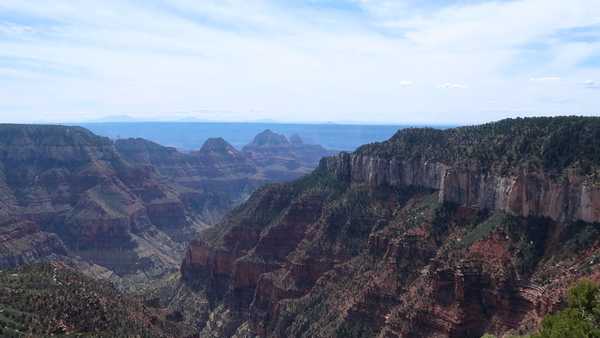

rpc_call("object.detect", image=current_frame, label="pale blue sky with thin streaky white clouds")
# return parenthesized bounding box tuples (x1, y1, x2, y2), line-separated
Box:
(0, 0, 600, 124)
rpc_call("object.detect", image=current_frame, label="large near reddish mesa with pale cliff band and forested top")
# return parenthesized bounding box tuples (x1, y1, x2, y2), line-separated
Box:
(181, 117, 600, 337)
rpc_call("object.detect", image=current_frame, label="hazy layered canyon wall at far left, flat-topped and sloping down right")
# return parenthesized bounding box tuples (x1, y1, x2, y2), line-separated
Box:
(0, 125, 202, 290)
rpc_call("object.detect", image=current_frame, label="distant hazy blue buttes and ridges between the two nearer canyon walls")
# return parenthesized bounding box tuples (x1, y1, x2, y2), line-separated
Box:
(115, 130, 331, 223)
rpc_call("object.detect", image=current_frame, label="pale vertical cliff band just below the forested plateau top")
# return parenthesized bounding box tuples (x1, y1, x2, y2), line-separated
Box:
(321, 153, 600, 222)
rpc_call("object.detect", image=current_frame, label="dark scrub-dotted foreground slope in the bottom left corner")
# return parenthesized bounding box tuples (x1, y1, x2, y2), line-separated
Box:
(0, 264, 180, 337)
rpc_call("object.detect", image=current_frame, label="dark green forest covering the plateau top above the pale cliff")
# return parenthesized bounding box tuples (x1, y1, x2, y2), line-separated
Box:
(358, 116, 600, 180)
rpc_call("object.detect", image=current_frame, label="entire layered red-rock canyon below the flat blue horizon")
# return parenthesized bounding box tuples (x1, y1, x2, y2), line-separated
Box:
(0, 117, 600, 338)
